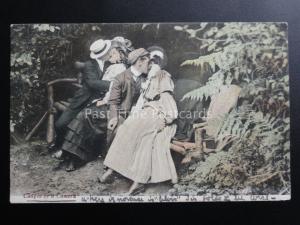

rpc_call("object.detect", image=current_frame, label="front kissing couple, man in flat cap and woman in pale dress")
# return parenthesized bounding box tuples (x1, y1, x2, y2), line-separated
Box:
(100, 46, 178, 194)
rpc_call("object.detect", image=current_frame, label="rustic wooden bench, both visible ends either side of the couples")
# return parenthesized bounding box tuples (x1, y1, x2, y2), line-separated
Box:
(25, 61, 241, 163)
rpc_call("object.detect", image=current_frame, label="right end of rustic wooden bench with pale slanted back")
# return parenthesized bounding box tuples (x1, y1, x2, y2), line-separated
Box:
(171, 85, 241, 164)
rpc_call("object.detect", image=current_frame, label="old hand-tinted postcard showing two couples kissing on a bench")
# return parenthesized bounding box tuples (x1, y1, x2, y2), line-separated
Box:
(10, 22, 291, 203)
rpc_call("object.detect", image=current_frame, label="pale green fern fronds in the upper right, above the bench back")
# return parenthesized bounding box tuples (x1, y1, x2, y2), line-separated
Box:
(177, 23, 288, 100)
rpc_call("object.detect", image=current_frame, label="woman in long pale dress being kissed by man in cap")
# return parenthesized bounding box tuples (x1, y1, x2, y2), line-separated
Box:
(100, 46, 178, 194)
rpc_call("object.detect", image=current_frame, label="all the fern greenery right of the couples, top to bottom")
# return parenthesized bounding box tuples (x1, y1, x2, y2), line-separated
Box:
(175, 23, 290, 194)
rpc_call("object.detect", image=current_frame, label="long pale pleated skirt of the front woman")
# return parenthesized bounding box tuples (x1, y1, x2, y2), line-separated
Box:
(104, 108, 177, 183)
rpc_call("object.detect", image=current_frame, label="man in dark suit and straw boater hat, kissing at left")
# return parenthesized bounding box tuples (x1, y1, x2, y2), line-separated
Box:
(49, 39, 112, 150)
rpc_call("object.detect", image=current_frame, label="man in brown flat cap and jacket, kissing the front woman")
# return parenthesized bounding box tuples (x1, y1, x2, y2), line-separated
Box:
(107, 48, 150, 145)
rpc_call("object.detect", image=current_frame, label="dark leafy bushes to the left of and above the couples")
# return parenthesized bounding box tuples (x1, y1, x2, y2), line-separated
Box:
(10, 23, 202, 137)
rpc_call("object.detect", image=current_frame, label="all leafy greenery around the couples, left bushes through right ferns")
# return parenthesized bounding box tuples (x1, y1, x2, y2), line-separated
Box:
(10, 23, 290, 194)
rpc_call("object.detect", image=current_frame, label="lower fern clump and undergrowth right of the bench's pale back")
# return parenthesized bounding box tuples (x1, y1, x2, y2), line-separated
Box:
(176, 107, 290, 194)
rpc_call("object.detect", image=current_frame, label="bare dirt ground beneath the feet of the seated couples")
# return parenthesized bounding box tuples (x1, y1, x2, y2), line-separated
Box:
(10, 142, 172, 198)
